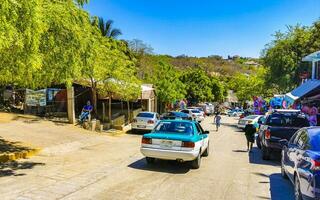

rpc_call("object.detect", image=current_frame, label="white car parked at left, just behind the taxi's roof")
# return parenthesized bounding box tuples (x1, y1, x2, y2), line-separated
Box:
(131, 112, 160, 133)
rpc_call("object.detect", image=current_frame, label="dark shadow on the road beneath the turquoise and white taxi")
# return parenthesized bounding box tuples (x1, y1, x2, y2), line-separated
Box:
(128, 158, 190, 174)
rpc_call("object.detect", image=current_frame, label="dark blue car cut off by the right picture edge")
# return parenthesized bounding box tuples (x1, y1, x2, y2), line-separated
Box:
(280, 127, 320, 200)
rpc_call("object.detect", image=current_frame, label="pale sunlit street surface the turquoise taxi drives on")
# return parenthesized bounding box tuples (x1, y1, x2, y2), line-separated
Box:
(0, 117, 294, 200)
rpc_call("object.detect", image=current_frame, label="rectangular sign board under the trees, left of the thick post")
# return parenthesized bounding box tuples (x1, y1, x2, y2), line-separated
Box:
(26, 89, 47, 106)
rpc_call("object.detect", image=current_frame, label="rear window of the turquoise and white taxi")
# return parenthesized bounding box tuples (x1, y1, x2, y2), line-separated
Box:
(152, 121, 193, 135)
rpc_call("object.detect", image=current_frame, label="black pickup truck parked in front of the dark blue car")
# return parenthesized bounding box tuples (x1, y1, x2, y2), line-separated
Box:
(257, 110, 309, 160)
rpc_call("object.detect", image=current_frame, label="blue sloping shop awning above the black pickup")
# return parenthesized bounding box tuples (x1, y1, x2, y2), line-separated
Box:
(285, 80, 320, 104)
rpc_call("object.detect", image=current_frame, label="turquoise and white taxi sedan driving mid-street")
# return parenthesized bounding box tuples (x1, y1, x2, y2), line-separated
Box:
(140, 120, 209, 169)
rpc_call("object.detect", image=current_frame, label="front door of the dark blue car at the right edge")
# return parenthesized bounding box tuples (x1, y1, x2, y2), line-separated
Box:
(285, 130, 303, 180)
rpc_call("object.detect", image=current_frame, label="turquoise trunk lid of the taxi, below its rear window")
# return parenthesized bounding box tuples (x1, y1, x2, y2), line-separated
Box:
(143, 132, 200, 142)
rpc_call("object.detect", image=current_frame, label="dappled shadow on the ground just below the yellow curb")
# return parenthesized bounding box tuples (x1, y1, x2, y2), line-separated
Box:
(0, 161, 45, 178)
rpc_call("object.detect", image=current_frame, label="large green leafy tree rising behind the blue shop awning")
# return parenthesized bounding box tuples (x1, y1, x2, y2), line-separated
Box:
(263, 22, 320, 93)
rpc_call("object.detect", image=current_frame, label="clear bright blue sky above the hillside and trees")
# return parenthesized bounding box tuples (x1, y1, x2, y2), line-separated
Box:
(85, 0, 320, 57)
